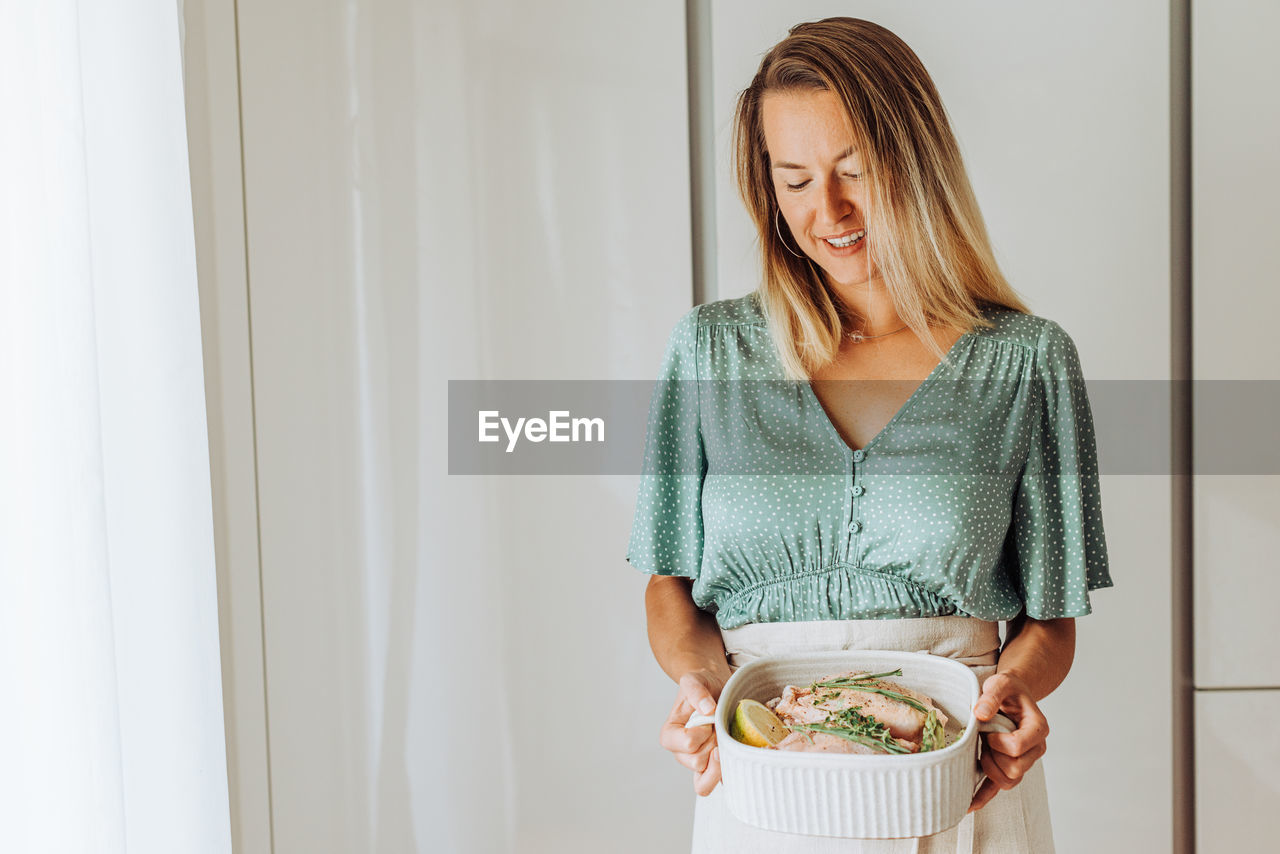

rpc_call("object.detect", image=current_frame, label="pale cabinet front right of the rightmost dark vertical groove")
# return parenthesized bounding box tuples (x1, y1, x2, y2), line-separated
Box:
(1192, 0, 1280, 851)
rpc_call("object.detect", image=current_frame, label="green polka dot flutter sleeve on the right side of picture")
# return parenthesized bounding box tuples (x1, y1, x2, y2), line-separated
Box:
(1005, 321, 1112, 620)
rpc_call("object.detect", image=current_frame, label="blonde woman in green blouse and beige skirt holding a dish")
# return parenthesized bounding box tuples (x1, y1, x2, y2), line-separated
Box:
(627, 18, 1111, 854)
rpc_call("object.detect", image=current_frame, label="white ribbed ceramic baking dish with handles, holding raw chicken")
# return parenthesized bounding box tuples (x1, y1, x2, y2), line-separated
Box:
(690, 650, 1014, 839)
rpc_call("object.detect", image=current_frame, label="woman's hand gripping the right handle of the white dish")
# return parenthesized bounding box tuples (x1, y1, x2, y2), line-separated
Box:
(969, 672, 1048, 813)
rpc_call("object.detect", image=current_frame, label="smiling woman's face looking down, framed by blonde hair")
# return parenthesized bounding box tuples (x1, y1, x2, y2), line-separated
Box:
(760, 90, 879, 286)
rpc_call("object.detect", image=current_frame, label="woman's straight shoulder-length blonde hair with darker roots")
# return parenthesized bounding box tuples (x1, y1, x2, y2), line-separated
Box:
(733, 18, 1029, 379)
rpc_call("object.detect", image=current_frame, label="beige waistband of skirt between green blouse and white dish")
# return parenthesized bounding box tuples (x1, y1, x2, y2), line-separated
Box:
(721, 617, 1000, 670)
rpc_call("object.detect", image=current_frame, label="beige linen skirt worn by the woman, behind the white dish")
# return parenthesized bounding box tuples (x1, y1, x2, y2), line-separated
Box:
(692, 617, 1053, 854)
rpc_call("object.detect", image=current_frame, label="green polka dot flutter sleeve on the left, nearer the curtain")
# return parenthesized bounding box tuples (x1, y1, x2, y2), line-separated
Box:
(627, 307, 707, 579)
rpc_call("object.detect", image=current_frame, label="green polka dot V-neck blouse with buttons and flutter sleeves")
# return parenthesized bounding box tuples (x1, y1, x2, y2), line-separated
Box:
(627, 294, 1111, 629)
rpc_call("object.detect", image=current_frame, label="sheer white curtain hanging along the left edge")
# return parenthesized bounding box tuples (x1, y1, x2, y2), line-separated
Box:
(0, 0, 230, 854)
